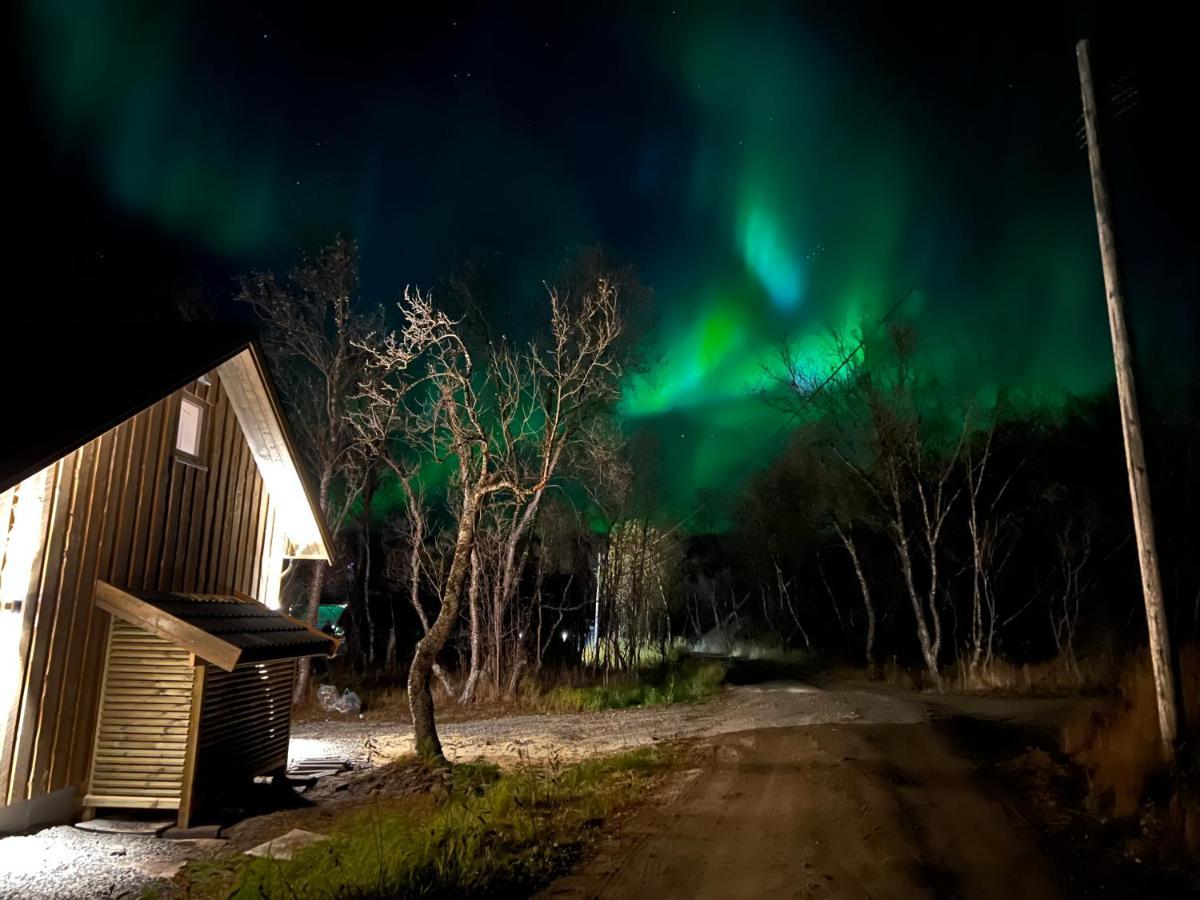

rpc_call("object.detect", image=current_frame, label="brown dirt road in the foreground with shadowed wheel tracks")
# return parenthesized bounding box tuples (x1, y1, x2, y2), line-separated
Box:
(544, 691, 1057, 900)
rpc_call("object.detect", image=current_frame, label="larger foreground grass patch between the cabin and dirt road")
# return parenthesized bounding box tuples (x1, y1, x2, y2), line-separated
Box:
(168, 748, 670, 898)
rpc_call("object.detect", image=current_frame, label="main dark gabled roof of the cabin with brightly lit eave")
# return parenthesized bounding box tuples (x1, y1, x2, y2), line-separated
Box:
(0, 323, 332, 560)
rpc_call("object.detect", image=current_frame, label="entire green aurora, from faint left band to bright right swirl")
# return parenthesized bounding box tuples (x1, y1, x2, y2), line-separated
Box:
(25, 7, 1190, 517)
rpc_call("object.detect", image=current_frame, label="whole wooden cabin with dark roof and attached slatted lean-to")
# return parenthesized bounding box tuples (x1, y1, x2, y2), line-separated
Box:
(0, 326, 336, 832)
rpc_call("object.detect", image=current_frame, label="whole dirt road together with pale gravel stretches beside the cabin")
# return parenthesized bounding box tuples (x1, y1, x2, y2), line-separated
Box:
(0, 682, 1078, 900)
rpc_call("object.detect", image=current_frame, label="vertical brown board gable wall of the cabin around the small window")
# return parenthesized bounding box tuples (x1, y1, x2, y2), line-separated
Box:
(0, 373, 278, 805)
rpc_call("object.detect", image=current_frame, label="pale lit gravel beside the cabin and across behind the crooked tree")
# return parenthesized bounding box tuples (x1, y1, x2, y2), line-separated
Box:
(0, 682, 925, 900)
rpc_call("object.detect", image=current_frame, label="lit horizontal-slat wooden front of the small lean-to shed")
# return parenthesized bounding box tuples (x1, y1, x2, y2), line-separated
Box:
(84, 620, 196, 809)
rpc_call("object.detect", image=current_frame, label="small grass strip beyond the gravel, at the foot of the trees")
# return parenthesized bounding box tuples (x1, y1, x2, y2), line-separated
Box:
(542, 656, 726, 712)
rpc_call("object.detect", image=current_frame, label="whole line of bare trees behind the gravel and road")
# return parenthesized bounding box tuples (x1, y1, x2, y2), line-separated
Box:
(239, 239, 1200, 756)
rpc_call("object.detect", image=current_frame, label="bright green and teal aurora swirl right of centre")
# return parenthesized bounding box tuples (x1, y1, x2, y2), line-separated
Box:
(623, 22, 1111, 518)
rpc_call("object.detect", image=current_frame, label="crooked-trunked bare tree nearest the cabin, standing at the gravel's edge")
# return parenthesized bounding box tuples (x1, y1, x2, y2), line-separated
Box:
(361, 278, 622, 758)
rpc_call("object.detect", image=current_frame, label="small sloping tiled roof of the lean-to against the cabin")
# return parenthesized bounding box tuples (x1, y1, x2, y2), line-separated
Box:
(96, 581, 338, 671)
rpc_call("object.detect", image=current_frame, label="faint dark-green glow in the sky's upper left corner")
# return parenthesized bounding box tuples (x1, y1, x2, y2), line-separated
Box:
(25, 0, 284, 254)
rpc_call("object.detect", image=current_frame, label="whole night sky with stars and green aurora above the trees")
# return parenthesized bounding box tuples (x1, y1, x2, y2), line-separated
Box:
(7, 0, 1198, 518)
